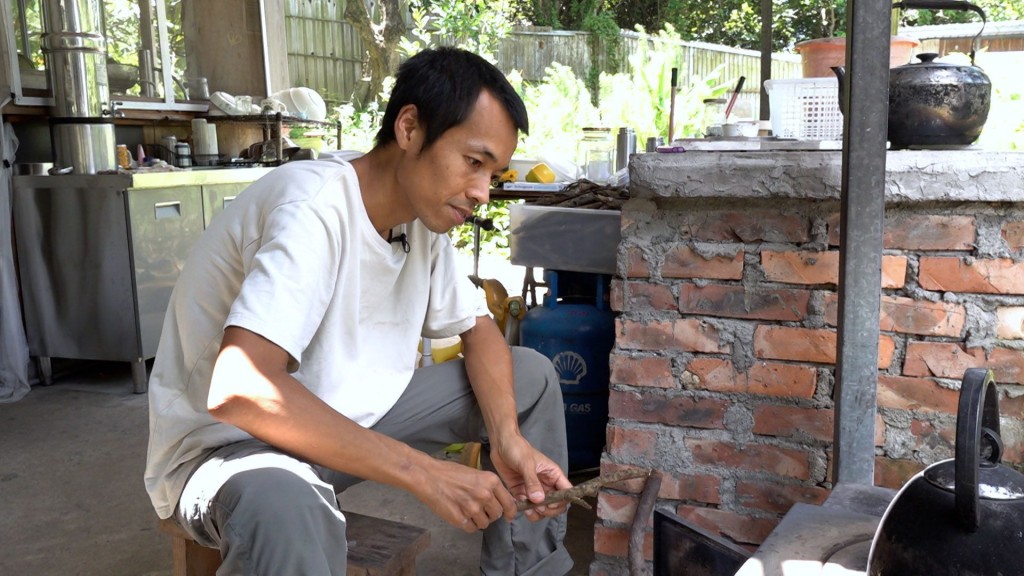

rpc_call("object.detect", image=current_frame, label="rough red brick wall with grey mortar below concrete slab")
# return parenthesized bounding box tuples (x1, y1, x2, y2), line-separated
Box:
(591, 198, 1024, 575)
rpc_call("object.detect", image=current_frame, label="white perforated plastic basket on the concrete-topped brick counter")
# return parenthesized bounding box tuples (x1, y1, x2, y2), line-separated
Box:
(765, 78, 843, 140)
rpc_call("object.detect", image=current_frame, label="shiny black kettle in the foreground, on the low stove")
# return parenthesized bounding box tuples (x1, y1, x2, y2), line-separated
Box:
(867, 368, 1024, 576)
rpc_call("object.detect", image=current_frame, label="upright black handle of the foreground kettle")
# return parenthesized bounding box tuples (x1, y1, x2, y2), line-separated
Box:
(953, 368, 1001, 532)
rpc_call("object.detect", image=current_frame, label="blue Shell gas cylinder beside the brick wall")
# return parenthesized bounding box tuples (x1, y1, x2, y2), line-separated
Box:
(519, 270, 615, 470)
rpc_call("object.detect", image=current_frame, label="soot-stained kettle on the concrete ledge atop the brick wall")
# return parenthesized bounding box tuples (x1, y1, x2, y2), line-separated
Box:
(831, 0, 992, 150)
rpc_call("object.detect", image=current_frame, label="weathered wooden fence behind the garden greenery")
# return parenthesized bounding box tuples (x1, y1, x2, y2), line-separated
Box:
(286, 0, 801, 110)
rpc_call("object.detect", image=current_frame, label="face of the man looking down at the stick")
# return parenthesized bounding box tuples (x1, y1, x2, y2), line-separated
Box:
(399, 90, 518, 234)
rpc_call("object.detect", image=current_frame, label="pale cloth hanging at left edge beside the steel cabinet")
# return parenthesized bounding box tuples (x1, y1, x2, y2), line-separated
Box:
(0, 118, 31, 403)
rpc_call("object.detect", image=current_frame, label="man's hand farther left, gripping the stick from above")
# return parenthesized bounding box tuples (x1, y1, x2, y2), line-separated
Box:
(415, 460, 516, 532)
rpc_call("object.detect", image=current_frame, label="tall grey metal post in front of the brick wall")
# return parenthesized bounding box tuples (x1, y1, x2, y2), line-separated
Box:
(834, 0, 892, 486)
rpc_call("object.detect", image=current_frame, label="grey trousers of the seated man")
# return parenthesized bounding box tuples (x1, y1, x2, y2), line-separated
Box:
(176, 347, 572, 576)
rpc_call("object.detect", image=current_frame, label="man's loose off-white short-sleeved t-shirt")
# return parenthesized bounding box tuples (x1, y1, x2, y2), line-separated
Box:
(145, 159, 486, 518)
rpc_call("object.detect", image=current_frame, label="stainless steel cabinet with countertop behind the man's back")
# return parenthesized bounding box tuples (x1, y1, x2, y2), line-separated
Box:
(13, 166, 268, 393)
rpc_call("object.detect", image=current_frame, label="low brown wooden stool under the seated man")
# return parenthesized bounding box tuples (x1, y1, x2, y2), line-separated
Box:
(160, 512, 430, 576)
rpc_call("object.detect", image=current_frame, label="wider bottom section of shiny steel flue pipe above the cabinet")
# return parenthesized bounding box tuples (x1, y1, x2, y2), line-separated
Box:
(50, 118, 118, 174)
